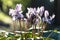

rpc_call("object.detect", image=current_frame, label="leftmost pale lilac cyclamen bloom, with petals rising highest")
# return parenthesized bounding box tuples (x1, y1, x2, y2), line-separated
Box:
(9, 4, 24, 20)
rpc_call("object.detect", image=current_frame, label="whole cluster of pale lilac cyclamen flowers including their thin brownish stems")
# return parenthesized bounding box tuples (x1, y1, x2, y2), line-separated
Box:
(9, 4, 55, 36)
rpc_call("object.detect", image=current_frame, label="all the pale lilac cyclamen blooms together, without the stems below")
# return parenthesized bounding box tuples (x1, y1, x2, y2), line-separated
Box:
(9, 4, 55, 24)
